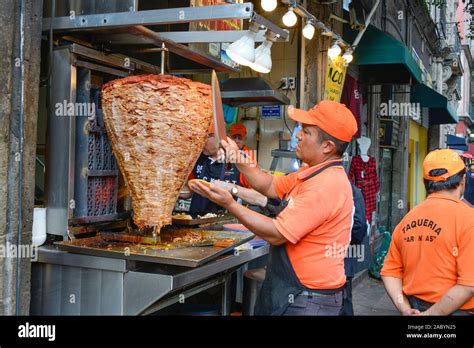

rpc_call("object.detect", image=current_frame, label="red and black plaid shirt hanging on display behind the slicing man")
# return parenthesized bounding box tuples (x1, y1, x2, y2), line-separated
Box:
(349, 155, 379, 223)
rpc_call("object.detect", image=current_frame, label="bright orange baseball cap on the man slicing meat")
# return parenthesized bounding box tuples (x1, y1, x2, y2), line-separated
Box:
(288, 100, 357, 143)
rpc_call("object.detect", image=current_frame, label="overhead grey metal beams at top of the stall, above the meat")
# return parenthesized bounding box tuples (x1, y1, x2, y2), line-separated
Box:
(43, 2, 289, 72)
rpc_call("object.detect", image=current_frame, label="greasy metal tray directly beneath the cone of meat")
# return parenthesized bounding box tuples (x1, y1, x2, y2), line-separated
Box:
(55, 230, 255, 267)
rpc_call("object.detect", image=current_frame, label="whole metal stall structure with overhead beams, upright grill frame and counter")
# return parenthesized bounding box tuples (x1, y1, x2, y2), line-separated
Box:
(40, 3, 282, 315)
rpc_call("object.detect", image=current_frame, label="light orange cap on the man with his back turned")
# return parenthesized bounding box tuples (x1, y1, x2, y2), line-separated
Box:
(423, 149, 465, 182)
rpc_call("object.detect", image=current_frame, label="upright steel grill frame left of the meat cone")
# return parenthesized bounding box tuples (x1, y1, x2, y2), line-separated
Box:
(45, 44, 159, 234)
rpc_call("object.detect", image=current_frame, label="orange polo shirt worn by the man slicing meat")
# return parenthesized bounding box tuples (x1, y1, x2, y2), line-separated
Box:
(273, 161, 354, 289)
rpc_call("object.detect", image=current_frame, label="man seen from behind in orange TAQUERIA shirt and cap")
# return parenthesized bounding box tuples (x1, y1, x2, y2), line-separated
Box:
(380, 149, 474, 315)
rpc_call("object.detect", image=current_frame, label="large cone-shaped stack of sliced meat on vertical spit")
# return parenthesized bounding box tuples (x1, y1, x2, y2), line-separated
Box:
(102, 75, 212, 231)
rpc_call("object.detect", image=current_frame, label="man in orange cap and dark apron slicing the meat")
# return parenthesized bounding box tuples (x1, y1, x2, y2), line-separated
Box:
(191, 100, 357, 315)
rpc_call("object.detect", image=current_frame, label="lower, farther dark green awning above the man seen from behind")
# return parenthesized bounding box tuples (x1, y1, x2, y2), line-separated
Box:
(411, 84, 459, 126)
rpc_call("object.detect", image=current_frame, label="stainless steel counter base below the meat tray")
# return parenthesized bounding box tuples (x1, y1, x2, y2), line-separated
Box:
(31, 245, 269, 315)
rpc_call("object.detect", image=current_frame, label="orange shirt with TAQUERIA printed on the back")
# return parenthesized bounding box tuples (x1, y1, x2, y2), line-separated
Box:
(380, 192, 474, 309)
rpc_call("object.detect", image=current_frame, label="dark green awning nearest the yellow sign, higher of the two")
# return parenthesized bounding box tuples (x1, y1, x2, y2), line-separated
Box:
(354, 26, 422, 84)
